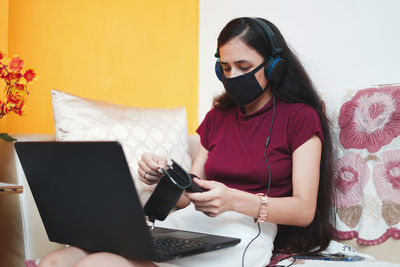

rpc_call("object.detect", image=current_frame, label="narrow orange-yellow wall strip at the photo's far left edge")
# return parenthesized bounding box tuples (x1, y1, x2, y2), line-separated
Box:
(0, 0, 8, 133)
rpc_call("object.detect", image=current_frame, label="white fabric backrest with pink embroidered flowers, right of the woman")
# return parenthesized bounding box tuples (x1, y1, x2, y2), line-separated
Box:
(334, 85, 400, 245)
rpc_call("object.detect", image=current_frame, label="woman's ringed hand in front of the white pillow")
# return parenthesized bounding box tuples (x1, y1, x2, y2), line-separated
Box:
(138, 153, 167, 185)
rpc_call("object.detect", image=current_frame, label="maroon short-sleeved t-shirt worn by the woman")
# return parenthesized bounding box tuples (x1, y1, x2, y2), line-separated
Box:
(197, 100, 323, 197)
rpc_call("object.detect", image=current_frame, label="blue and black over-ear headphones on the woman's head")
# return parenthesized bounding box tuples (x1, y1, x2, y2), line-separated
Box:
(215, 18, 287, 82)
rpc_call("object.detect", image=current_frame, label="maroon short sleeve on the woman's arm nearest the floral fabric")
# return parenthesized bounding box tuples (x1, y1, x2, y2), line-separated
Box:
(288, 105, 324, 152)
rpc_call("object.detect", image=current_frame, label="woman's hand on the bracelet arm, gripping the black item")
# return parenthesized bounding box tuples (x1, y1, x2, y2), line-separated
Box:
(184, 178, 233, 217)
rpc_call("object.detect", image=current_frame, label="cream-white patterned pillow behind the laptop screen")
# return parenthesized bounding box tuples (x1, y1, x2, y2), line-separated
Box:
(51, 90, 191, 203)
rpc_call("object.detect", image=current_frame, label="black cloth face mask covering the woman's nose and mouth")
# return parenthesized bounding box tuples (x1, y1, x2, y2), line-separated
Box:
(222, 61, 269, 106)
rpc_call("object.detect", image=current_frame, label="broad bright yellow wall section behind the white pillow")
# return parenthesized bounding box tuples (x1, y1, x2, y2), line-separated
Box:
(2, 0, 198, 133)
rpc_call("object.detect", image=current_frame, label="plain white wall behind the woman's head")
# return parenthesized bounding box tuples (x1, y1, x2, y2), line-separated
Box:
(199, 0, 400, 122)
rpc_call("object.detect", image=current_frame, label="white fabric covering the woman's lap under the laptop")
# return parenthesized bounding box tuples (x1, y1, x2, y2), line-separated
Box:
(156, 204, 277, 267)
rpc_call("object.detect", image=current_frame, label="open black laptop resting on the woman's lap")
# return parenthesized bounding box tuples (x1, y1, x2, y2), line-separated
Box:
(15, 142, 240, 261)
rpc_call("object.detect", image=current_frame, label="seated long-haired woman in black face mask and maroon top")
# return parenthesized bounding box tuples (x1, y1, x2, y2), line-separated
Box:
(41, 18, 332, 266)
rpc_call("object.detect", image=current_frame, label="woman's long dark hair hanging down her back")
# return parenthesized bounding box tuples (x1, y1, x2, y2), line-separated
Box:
(214, 18, 335, 253)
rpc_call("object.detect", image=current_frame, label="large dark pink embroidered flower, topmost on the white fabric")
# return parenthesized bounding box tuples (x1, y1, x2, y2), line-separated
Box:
(338, 86, 400, 153)
